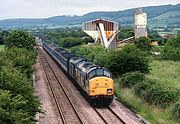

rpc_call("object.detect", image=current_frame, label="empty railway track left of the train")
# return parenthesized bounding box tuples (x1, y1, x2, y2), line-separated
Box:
(40, 52, 84, 124)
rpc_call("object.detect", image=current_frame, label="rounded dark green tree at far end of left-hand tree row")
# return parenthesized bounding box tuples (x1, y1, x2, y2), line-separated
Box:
(5, 31, 36, 50)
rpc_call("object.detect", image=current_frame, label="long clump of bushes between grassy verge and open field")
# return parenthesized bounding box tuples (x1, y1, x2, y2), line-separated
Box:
(120, 72, 180, 107)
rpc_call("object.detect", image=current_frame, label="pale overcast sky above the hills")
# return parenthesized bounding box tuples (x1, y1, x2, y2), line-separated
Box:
(0, 0, 180, 20)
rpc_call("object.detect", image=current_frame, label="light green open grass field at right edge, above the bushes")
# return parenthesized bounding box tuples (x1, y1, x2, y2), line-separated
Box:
(147, 60, 180, 89)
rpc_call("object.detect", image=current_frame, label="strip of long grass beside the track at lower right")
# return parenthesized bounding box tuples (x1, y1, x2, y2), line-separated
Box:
(115, 84, 178, 124)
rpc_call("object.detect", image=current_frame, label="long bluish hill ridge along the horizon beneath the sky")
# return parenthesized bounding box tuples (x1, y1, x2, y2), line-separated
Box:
(0, 4, 180, 28)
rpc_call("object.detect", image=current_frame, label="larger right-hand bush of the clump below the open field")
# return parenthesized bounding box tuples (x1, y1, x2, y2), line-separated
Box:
(135, 79, 180, 107)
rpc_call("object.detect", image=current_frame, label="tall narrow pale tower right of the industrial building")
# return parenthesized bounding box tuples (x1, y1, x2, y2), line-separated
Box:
(134, 9, 147, 39)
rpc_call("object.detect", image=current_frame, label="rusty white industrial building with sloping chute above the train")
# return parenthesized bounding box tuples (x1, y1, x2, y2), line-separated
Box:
(82, 19, 118, 49)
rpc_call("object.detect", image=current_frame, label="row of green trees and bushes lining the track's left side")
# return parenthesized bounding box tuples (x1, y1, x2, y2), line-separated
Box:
(0, 31, 41, 124)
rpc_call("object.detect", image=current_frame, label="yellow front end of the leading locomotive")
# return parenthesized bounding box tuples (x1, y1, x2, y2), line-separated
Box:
(89, 76, 114, 98)
